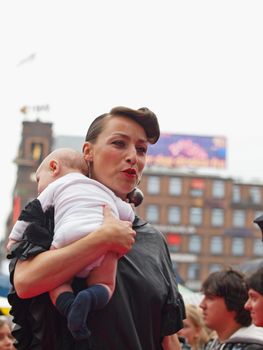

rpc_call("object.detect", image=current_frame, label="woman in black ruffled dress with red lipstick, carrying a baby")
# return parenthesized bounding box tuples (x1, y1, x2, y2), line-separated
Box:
(9, 107, 185, 350)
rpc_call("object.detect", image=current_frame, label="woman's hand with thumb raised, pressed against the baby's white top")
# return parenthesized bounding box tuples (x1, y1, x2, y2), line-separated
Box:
(101, 206, 136, 255)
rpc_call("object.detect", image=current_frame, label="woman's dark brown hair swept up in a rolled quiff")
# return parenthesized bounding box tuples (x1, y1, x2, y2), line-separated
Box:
(85, 106, 160, 144)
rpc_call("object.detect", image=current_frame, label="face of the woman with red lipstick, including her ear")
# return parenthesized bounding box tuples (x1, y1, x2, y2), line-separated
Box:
(83, 116, 148, 199)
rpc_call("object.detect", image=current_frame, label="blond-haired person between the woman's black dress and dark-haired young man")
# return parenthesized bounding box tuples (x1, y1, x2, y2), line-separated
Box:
(178, 304, 210, 350)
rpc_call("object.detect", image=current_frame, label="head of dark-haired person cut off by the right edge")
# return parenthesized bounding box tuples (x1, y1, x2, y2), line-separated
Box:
(245, 267, 263, 327)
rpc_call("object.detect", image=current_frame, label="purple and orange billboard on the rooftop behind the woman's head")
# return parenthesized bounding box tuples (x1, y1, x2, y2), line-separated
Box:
(147, 133, 226, 169)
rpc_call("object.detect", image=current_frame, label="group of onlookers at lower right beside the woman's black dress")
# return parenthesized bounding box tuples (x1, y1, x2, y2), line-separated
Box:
(178, 268, 263, 350)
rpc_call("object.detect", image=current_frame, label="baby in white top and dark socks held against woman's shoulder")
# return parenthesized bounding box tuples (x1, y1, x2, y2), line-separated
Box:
(7, 148, 134, 339)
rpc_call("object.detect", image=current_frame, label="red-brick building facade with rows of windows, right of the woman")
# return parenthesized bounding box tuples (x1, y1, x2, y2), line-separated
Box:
(137, 168, 263, 290)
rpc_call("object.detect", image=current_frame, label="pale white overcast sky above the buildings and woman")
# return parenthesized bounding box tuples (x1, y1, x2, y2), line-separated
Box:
(0, 0, 263, 237)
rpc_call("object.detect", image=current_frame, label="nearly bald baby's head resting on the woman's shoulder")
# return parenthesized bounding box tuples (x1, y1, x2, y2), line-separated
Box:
(36, 148, 89, 193)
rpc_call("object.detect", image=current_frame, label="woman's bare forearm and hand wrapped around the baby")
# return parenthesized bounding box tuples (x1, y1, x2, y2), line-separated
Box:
(14, 207, 135, 298)
